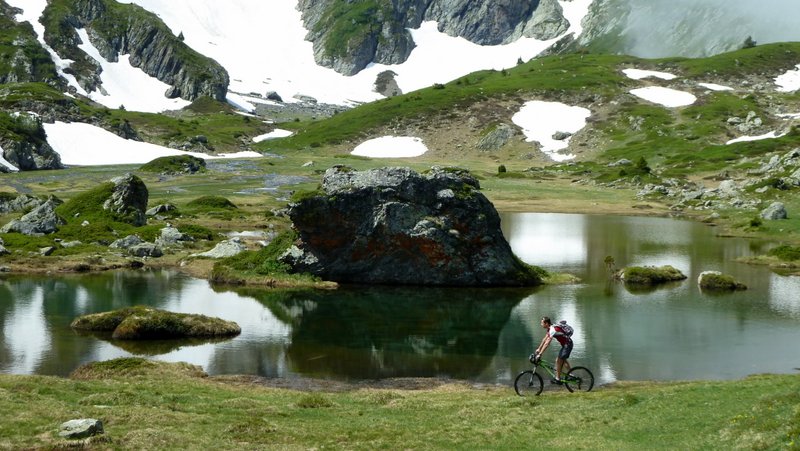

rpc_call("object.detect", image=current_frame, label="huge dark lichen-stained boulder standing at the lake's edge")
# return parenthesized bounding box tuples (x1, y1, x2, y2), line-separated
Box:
(281, 166, 541, 286)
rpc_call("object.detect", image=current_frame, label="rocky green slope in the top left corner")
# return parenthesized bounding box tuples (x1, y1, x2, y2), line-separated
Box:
(0, 0, 58, 84)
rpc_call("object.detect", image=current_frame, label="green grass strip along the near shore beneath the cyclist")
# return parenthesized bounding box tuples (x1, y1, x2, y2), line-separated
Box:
(0, 368, 800, 450)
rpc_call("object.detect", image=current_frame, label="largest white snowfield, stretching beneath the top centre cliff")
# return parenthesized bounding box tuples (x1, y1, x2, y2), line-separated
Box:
(119, 0, 591, 105)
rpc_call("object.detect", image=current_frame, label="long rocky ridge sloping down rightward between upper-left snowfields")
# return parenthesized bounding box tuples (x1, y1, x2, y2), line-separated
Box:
(42, 0, 229, 101)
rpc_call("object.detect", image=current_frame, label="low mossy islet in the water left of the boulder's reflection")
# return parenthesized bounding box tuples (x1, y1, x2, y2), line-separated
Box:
(70, 306, 242, 340)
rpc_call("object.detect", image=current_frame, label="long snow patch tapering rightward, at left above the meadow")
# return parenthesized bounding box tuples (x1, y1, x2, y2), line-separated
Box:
(43, 122, 262, 166)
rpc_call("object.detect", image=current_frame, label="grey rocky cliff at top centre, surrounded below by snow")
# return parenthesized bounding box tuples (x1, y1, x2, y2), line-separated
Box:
(298, 0, 569, 75)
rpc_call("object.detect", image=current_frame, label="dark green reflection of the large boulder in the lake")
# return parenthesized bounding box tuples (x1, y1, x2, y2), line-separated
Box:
(241, 287, 530, 379)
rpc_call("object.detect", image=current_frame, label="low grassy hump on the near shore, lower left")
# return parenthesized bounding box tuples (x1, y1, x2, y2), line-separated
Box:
(69, 357, 208, 380)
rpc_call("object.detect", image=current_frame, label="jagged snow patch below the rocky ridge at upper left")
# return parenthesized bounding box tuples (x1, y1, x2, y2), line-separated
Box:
(78, 28, 191, 113)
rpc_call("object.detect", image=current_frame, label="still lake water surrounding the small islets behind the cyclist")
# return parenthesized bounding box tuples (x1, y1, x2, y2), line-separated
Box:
(0, 213, 800, 383)
